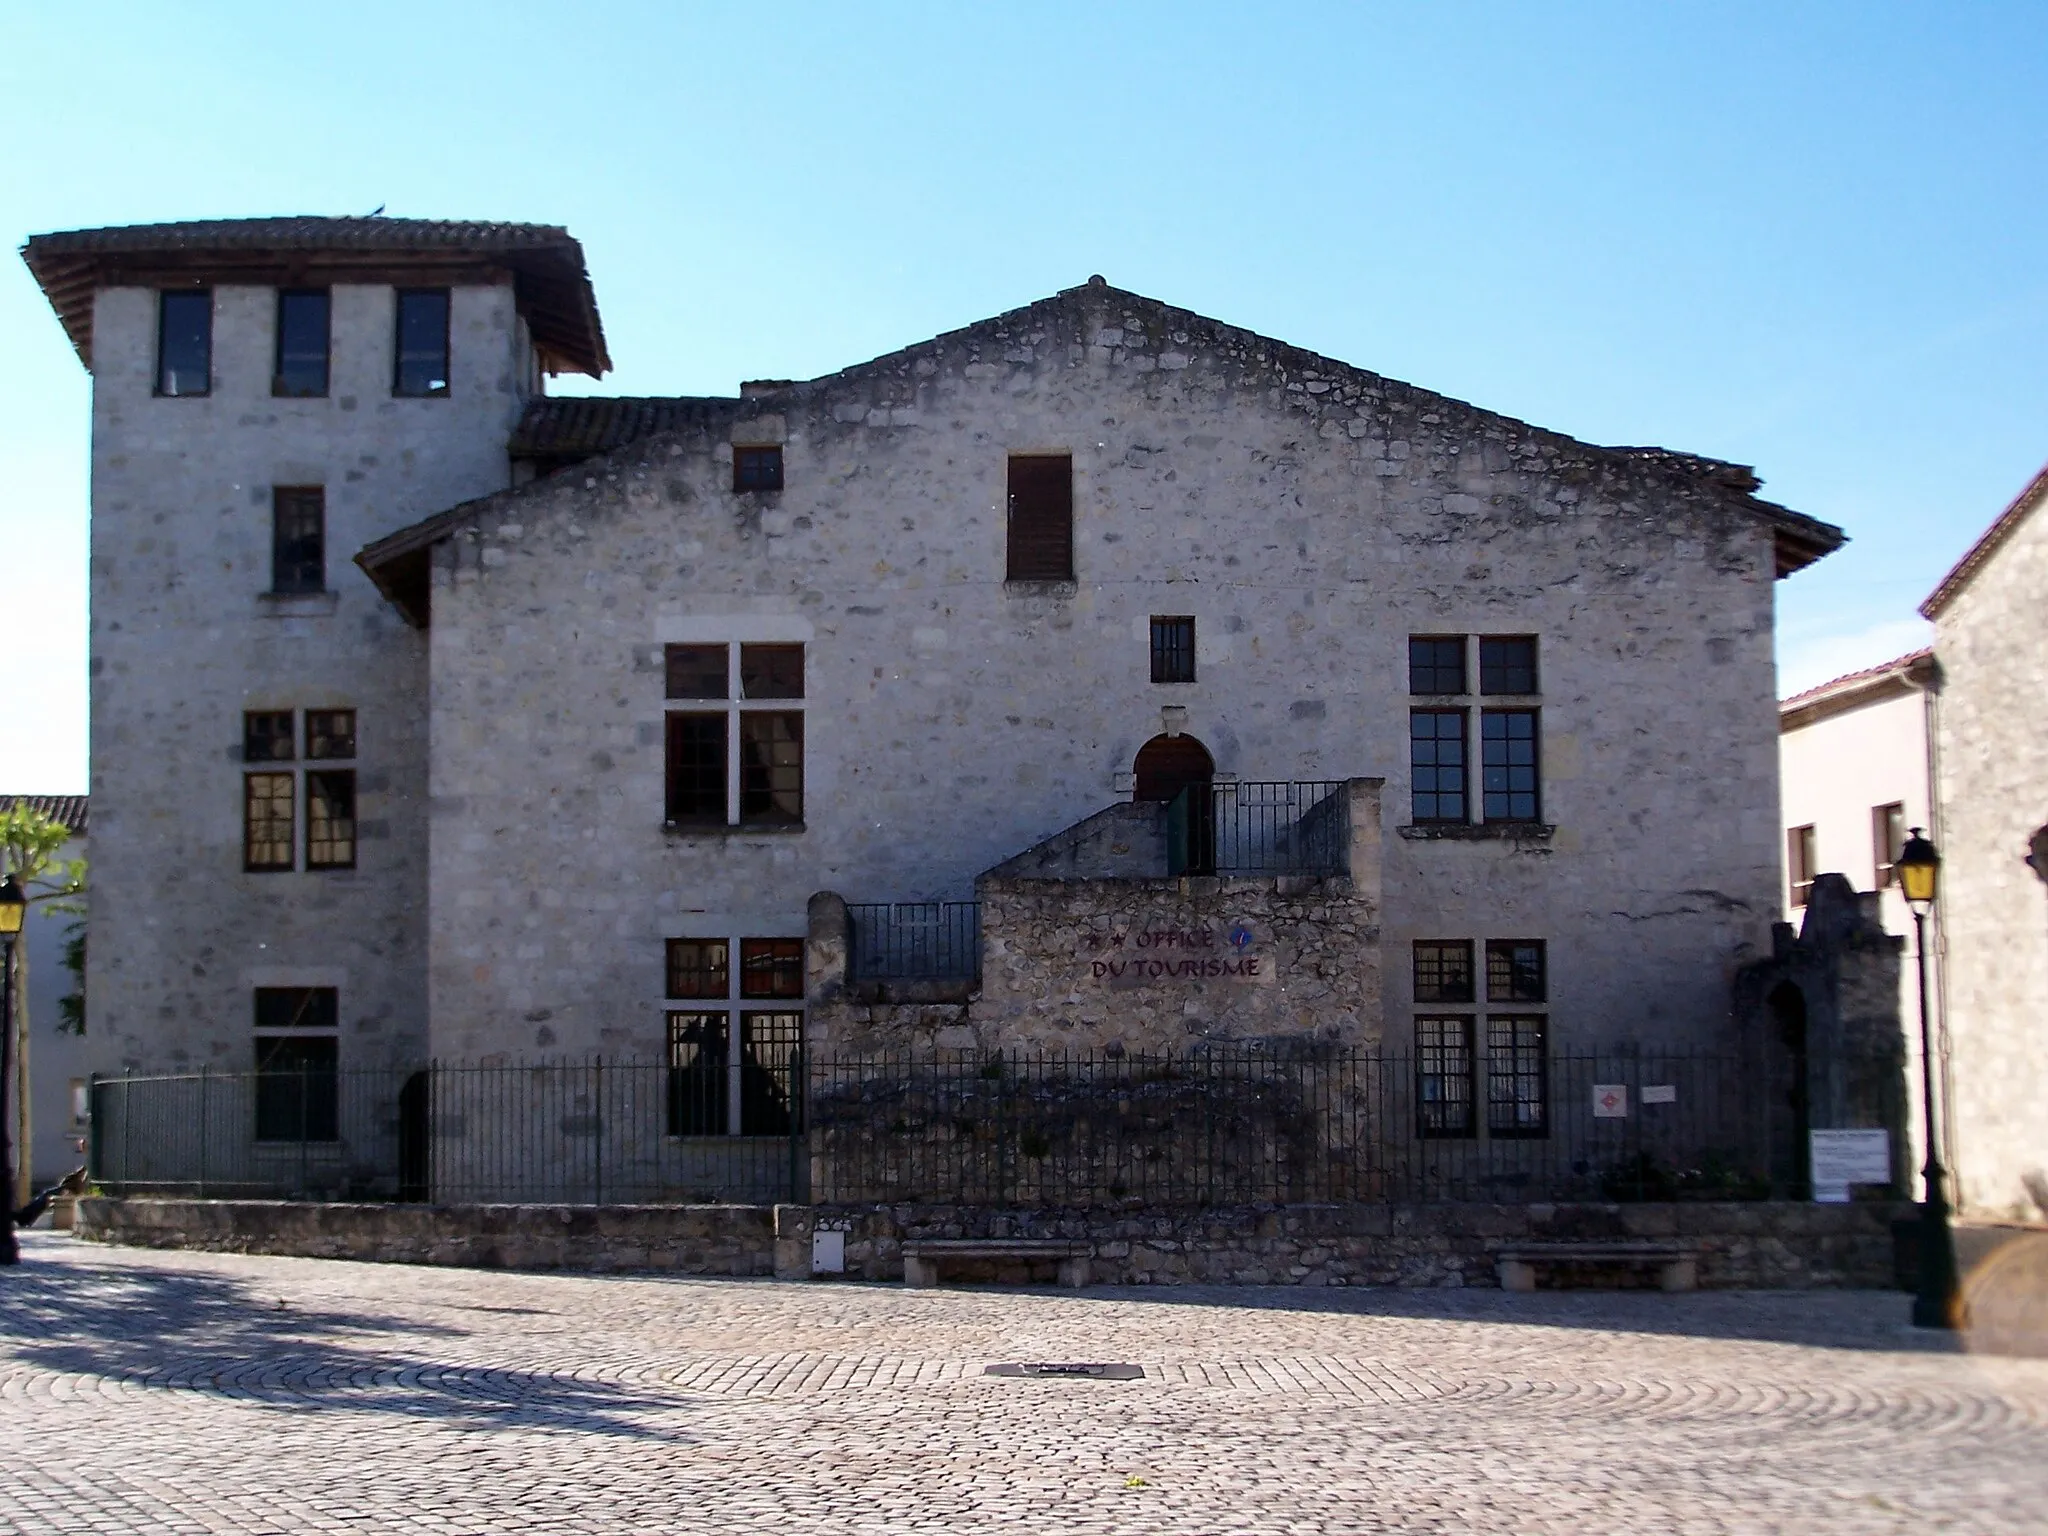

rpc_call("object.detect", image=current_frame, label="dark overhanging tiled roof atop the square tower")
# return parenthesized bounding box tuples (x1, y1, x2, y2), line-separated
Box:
(20, 213, 610, 375)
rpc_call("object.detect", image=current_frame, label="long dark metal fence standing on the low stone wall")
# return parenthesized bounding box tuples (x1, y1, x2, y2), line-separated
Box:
(92, 1049, 1806, 1206)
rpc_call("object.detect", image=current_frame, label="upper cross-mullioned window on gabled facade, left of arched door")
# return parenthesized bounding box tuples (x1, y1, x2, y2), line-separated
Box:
(664, 643, 805, 829)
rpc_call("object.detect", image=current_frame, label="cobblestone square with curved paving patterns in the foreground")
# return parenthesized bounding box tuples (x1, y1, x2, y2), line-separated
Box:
(0, 1233, 2048, 1536)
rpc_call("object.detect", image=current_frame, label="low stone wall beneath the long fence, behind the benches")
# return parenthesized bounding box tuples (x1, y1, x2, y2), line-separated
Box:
(78, 1198, 1913, 1288)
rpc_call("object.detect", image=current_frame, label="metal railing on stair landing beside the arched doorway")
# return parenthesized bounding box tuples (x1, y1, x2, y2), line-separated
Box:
(1165, 780, 1352, 874)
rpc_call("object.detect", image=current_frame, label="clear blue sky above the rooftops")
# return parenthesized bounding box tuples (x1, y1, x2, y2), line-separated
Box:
(0, 0, 2048, 793)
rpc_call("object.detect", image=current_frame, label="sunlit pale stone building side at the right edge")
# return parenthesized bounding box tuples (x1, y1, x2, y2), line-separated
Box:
(1921, 471, 2048, 1214)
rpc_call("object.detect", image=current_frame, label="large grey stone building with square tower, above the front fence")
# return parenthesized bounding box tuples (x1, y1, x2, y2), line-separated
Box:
(25, 219, 1841, 1179)
